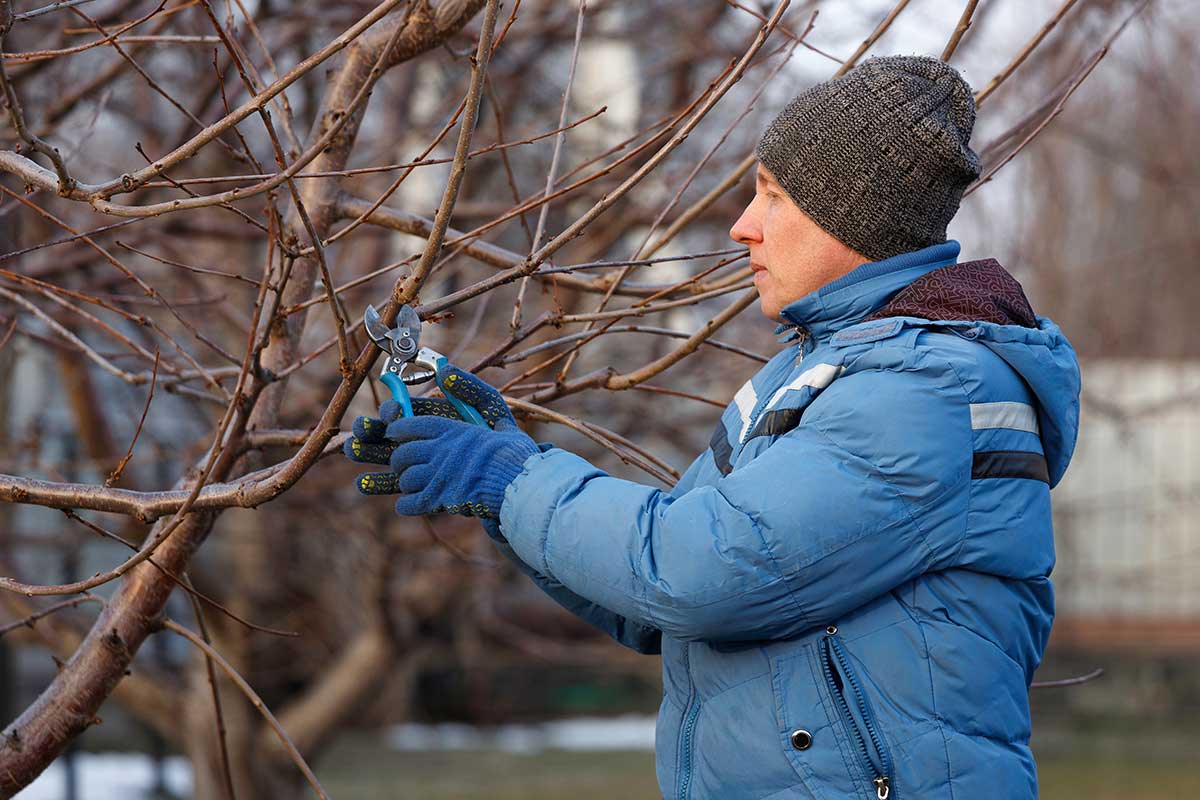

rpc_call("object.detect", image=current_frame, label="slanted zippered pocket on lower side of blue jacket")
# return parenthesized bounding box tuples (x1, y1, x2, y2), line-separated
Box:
(817, 626, 896, 800)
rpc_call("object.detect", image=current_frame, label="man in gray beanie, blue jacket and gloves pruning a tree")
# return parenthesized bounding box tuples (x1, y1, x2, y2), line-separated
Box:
(348, 56, 1079, 800)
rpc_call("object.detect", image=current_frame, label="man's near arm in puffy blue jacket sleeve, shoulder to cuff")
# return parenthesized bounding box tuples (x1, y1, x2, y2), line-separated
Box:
(500, 350, 972, 640)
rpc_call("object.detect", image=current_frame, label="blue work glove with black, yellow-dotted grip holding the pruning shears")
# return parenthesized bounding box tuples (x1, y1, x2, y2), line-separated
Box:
(343, 365, 539, 519)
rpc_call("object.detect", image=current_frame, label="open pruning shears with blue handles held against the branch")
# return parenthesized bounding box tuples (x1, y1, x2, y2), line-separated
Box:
(362, 305, 487, 427)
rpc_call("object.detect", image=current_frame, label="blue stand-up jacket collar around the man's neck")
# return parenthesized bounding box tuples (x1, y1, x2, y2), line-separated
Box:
(775, 239, 960, 342)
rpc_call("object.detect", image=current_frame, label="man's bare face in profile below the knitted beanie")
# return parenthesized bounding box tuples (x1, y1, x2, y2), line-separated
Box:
(730, 164, 870, 320)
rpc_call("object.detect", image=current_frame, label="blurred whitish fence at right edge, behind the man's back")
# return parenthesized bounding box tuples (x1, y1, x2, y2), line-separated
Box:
(1054, 360, 1200, 621)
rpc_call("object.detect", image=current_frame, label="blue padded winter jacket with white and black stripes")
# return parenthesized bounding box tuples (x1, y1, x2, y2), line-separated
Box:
(487, 241, 1079, 800)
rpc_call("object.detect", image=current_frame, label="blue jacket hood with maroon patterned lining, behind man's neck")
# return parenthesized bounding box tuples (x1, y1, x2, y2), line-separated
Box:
(869, 258, 1080, 487)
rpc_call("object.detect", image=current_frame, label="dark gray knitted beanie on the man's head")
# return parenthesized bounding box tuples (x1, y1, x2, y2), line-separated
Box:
(755, 55, 979, 260)
